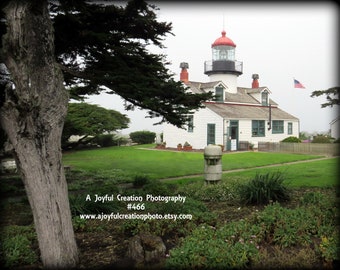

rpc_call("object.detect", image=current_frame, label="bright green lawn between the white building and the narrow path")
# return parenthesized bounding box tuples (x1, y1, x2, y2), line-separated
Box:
(63, 145, 326, 179)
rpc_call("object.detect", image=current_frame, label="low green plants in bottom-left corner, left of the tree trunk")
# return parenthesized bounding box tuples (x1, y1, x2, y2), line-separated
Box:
(0, 225, 39, 269)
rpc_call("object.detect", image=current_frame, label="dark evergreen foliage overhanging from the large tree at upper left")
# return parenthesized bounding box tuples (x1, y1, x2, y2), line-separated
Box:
(50, 0, 212, 126)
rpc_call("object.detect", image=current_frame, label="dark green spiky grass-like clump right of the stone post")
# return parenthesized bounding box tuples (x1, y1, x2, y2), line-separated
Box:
(238, 171, 289, 204)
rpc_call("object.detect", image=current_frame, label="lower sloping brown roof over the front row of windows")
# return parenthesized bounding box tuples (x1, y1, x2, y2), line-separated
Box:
(204, 102, 298, 120)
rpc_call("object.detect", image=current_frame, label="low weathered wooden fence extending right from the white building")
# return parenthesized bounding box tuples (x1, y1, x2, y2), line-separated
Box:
(258, 142, 340, 156)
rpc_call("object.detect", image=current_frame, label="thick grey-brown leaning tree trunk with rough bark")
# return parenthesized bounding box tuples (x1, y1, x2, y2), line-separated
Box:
(0, 0, 78, 269)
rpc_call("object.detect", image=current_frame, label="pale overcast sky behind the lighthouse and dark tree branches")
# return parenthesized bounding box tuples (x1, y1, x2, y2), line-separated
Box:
(87, 1, 339, 134)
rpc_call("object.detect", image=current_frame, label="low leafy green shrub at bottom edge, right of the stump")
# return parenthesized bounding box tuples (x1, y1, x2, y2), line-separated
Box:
(166, 221, 261, 269)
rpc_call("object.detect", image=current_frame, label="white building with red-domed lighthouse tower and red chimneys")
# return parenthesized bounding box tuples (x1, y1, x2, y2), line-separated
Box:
(163, 31, 299, 150)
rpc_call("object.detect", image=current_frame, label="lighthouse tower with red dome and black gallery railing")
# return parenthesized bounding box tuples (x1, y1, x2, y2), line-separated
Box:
(204, 30, 243, 93)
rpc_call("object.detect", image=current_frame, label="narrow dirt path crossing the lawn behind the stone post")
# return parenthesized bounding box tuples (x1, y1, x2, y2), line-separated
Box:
(160, 156, 338, 181)
